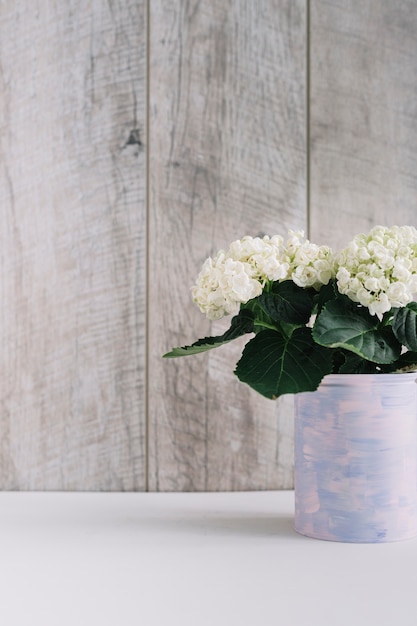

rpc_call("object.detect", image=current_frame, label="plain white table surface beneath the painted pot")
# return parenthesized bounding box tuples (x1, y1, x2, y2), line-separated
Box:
(0, 491, 417, 626)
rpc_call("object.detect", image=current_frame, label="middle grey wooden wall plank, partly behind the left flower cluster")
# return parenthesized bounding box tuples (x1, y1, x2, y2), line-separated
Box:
(149, 0, 306, 491)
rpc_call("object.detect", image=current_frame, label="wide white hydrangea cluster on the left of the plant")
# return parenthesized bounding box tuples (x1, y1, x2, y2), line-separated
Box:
(191, 231, 334, 320)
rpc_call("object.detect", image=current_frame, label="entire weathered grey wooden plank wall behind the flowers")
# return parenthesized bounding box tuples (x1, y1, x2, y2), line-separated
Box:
(0, 0, 417, 491)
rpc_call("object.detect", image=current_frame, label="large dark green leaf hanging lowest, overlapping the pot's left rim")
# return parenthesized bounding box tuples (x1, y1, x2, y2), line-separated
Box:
(235, 327, 332, 399)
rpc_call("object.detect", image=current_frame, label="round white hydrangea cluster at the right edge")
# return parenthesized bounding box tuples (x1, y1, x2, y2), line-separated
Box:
(336, 226, 417, 319)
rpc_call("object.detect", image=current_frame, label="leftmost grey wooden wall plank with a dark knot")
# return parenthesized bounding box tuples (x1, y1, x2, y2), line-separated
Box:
(0, 0, 146, 490)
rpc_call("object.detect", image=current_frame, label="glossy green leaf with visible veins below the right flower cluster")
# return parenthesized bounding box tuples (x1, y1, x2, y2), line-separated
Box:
(313, 300, 401, 363)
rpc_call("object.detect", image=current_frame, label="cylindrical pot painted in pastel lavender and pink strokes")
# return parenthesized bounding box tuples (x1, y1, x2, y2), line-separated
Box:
(294, 373, 417, 543)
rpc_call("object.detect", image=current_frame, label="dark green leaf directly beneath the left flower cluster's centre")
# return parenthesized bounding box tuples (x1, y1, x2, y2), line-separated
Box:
(257, 280, 313, 324)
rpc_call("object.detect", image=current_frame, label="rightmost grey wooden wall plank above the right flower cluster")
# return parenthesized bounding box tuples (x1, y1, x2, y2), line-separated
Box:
(310, 0, 417, 246)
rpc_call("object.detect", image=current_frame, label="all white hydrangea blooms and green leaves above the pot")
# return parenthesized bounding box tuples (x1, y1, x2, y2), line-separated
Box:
(164, 226, 417, 399)
